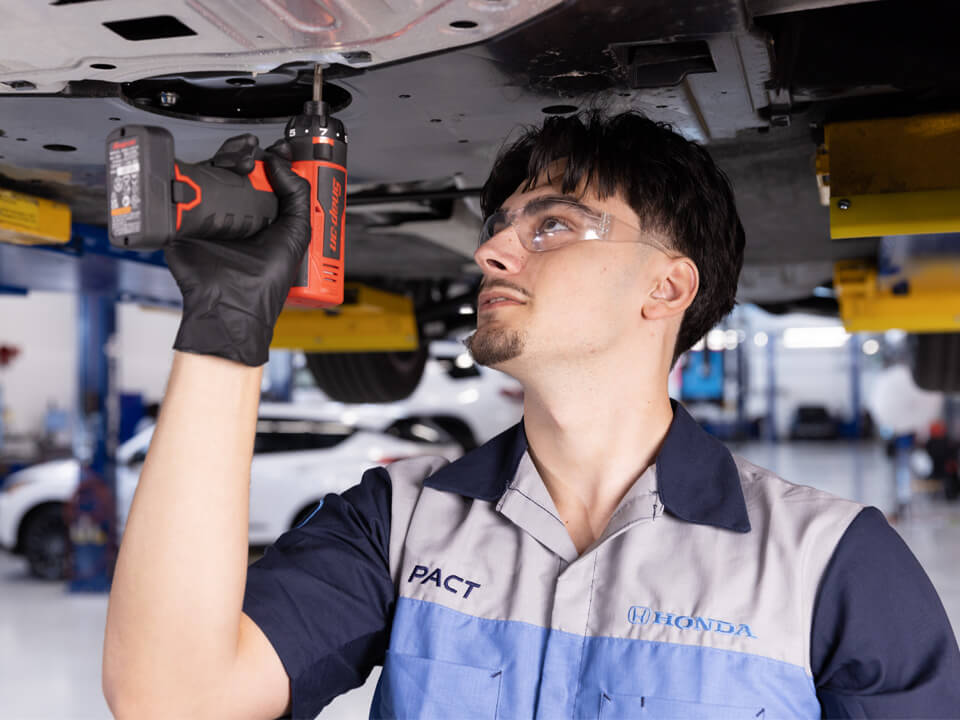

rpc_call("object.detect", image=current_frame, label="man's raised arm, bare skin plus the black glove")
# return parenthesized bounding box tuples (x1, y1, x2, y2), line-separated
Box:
(103, 136, 310, 720)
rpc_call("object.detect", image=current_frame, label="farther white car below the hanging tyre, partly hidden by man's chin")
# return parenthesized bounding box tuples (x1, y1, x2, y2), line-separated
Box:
(290, 340, 523, 451)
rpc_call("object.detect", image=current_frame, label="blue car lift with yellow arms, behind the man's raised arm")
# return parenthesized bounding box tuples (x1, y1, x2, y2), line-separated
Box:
(0, 190, 418, 592)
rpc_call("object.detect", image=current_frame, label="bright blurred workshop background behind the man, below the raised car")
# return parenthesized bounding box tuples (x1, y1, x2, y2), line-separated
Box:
(0, 292, 960, 717)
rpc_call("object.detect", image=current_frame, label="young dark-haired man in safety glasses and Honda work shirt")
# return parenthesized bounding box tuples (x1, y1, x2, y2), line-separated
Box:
(104, 114, 960, 719)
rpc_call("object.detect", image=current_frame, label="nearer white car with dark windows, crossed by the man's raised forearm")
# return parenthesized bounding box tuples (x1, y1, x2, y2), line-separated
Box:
(0, 403, 461, 579)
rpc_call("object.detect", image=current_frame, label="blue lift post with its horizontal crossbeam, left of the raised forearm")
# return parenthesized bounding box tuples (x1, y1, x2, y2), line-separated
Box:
(0, 223, 180, 592)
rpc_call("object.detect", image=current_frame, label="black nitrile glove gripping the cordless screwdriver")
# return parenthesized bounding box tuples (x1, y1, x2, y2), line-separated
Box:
(164, 135, 310, 367)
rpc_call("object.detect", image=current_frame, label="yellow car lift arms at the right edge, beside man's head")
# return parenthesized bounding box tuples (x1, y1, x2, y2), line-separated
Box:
(816, 113, 960, 333)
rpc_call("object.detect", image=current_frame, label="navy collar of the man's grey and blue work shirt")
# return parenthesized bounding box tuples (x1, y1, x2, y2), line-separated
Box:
(424, 400, 750, 533)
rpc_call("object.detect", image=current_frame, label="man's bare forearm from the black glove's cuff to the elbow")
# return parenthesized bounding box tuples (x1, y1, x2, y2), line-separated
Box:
(104, 353, 262, 717)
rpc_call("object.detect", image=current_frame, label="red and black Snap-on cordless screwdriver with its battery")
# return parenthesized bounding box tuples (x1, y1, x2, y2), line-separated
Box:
(107, 65, 347, 308)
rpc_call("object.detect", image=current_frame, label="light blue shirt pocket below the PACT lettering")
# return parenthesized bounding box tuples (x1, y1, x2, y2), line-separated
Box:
(371, 650, 503, 720)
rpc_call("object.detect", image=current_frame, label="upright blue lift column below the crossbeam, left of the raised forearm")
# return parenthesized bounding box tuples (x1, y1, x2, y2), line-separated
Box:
(68, 292, 120, 592)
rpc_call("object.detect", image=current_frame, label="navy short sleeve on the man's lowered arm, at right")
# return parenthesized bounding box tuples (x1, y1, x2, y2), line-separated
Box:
(810, 508, 960, 718)
